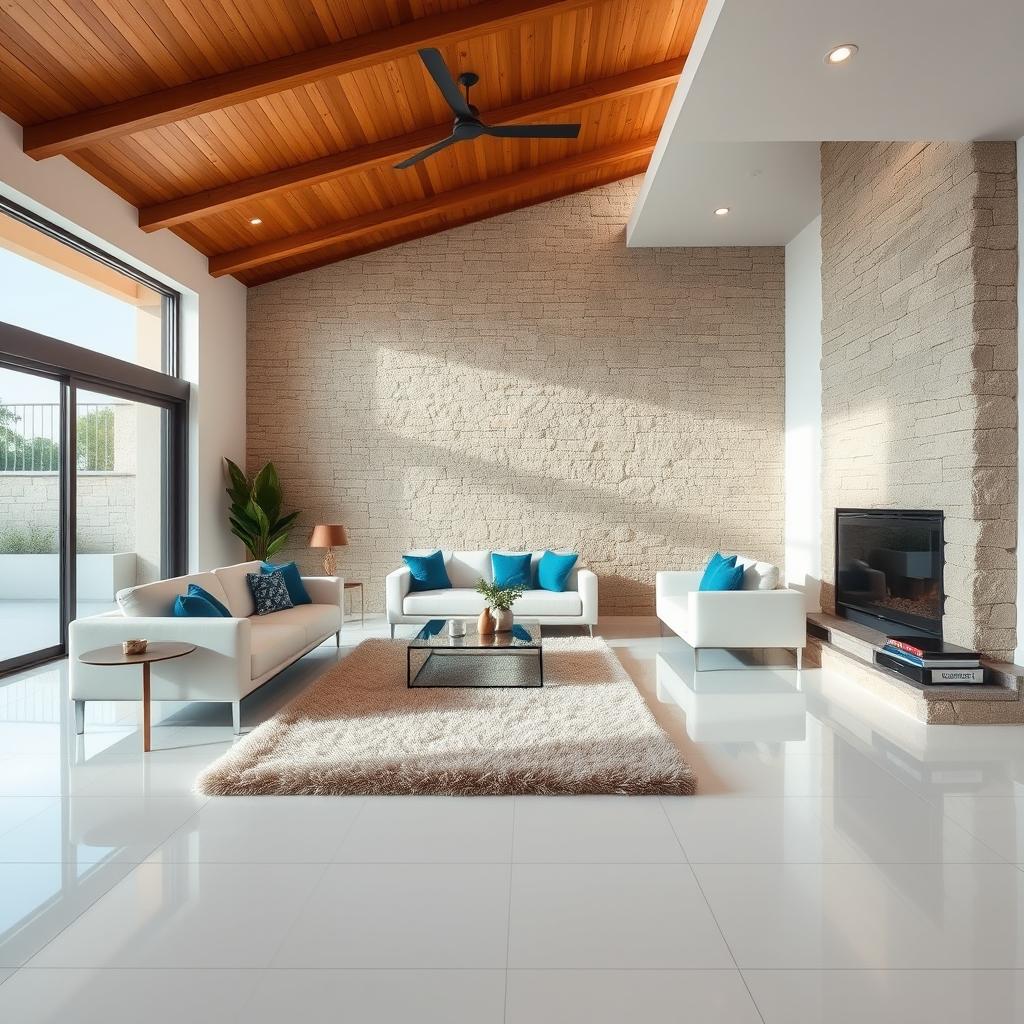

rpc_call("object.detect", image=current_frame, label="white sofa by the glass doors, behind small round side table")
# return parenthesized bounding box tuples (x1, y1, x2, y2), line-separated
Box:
(69, 562, 345, 733)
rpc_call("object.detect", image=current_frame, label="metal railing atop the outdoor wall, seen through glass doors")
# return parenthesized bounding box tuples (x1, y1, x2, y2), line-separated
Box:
(0, 402, 115, 473)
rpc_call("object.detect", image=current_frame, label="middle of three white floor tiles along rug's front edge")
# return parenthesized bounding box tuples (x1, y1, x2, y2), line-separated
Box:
(335, 797, 513, 863)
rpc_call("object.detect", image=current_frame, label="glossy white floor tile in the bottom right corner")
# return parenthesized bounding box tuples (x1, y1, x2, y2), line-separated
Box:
(743, 971, 1024, 1024)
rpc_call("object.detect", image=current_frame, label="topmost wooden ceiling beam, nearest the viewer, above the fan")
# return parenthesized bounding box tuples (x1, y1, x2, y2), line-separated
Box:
(23, 0, 599, 160)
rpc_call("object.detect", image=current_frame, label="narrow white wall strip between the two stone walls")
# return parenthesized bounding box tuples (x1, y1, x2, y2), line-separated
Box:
(785, 210, 821, 611)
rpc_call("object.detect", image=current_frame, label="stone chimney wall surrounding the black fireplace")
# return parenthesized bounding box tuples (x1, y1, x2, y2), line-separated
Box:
(821, 142, 1017, 656)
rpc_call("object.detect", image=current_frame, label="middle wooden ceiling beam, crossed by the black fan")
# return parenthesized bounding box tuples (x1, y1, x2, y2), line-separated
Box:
(138, 57, 684, 231)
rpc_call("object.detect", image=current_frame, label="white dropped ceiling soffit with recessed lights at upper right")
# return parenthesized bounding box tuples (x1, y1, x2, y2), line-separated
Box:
(628, 0, 1024, 246)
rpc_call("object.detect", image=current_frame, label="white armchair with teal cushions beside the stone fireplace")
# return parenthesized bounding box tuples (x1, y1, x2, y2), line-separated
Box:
(654, 555, 807, 669)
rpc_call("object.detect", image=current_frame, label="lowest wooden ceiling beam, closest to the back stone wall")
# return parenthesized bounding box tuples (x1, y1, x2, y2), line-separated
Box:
(209, 134, 657, 278)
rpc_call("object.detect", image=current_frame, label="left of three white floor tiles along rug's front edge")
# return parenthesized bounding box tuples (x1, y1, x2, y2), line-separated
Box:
(147, 797, 362, 863)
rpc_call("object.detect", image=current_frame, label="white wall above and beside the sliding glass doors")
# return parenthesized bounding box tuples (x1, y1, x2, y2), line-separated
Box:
(0, 115, 246, 568)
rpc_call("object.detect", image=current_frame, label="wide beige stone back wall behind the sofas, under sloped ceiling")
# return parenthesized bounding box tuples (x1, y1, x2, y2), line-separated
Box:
(248, 178, 783, 613)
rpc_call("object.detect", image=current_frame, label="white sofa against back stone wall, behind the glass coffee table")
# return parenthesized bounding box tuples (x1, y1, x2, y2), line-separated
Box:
(384, 548, 597, 637)
